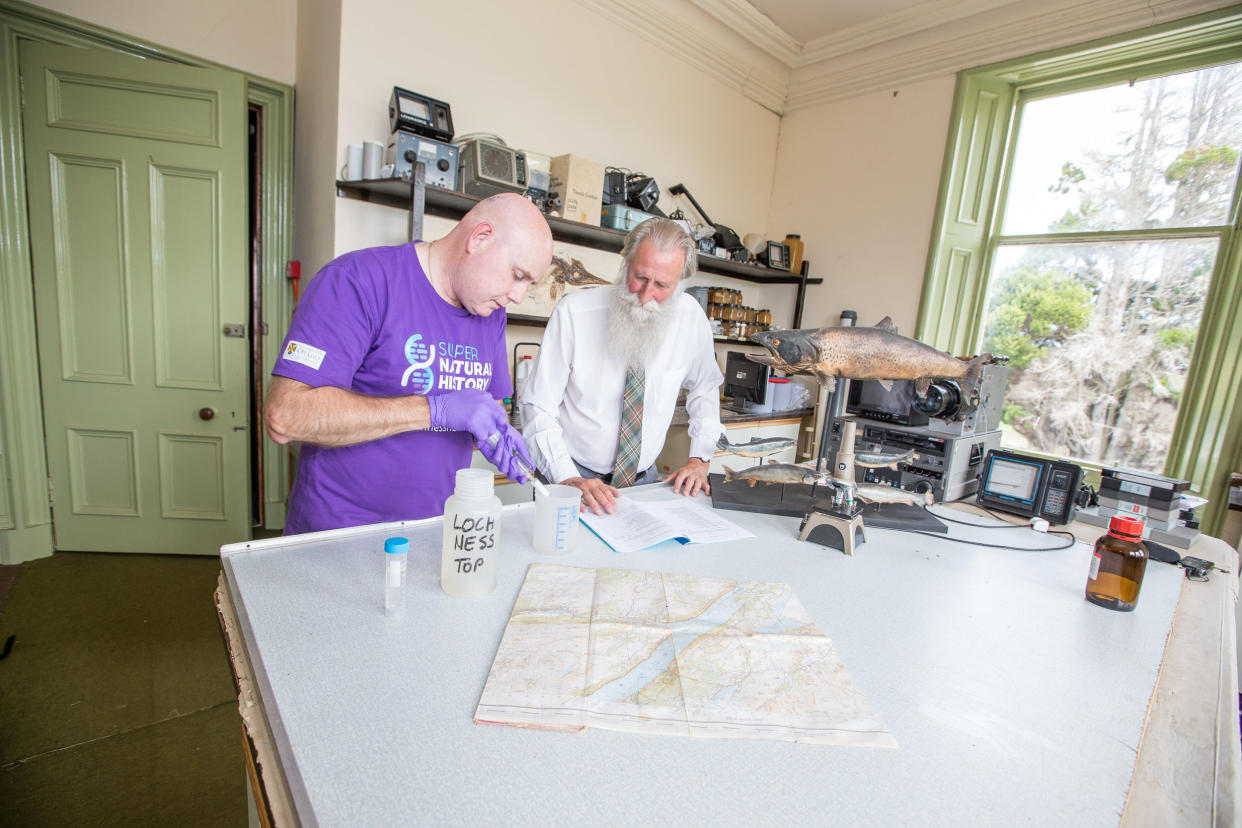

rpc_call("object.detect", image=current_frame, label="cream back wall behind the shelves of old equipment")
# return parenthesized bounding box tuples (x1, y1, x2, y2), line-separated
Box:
(315, 0, 795, 379)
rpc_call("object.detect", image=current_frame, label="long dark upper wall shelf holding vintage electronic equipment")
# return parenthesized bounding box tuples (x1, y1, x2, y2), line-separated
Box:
(337, 179, 823, 288)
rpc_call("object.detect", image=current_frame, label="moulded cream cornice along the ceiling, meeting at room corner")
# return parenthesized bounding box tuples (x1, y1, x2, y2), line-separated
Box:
(579, 0, 1236, 114)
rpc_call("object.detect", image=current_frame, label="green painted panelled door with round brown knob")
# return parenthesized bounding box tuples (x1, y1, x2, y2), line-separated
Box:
(20, 43, 251, 555)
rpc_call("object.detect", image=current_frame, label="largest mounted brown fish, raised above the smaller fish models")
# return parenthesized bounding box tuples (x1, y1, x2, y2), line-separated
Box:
(746, 317, 1004, 405)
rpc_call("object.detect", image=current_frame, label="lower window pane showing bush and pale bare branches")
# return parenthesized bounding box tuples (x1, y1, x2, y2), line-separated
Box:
(984, 238, 1218, 472)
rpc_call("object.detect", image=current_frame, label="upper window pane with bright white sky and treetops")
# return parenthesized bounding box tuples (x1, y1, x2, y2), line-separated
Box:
(1004, 63, 1242, 236)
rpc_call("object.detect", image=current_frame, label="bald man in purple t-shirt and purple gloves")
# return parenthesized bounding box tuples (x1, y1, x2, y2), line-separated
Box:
(265, 194, 551, 535)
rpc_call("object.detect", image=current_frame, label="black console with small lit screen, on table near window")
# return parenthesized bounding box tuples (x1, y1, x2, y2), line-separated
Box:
(975, 449, 1083, 526)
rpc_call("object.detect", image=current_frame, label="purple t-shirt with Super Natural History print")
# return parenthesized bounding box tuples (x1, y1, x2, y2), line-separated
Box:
(272, 243, 513, 535)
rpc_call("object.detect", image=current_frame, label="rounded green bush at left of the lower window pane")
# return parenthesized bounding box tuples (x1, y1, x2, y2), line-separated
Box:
(984, 266, 1092, 370)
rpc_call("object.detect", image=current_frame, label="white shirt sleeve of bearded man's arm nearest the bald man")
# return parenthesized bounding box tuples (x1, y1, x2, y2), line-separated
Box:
(518, 302, 578, 483)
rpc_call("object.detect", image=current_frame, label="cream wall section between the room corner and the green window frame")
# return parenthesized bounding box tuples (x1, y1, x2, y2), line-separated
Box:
(768, 76, 955, 335)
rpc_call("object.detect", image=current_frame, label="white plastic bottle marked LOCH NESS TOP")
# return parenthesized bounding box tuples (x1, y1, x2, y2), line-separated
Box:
(440, 468, 501, 598)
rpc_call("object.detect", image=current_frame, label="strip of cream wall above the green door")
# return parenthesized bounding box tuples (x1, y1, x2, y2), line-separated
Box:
(35, 0, 298, 84)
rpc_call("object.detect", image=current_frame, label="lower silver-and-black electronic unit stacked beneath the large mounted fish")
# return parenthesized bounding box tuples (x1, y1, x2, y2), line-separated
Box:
(828, 418, 1001, 503)
